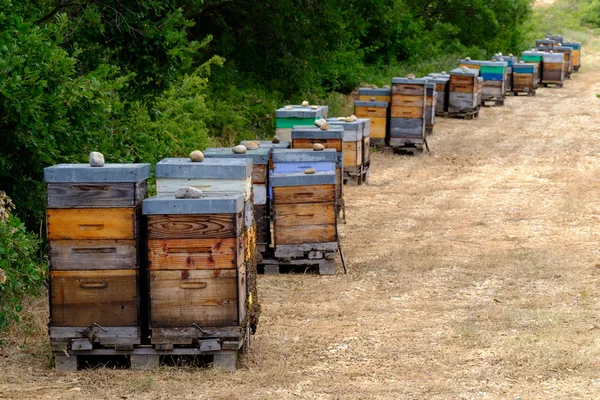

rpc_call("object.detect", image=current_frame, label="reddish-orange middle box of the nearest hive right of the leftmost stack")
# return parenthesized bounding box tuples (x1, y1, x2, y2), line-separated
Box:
(148, 238, 243, 271)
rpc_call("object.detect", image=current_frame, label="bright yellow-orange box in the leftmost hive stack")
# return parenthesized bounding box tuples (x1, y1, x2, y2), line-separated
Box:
(46, 208, 138, 240)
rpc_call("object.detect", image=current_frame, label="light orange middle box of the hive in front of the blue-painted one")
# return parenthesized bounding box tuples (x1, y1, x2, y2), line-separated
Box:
(274, 202, 335, 229)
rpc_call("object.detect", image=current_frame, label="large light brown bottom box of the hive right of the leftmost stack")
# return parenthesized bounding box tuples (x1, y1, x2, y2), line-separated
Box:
(150, 269, 238, 328)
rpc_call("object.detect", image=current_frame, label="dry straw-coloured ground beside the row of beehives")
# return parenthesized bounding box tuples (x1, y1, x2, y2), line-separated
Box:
(0, 37, 600, 400)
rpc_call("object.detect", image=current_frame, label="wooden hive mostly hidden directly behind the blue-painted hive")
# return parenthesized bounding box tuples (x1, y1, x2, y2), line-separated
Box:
(292, 126, 344, 203)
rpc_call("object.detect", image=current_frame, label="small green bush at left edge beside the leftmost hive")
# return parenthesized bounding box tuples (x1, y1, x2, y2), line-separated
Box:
(0, 192, 46, 330)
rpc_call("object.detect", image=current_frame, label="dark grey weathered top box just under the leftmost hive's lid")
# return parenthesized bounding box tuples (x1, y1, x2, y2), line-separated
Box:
(47, 181, 147, 208)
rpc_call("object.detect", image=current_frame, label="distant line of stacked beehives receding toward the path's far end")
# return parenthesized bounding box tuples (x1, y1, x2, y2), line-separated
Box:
(354, 36, 581, 152)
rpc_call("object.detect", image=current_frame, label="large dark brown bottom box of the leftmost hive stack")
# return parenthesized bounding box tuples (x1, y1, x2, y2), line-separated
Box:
(50, 270, 138, 327)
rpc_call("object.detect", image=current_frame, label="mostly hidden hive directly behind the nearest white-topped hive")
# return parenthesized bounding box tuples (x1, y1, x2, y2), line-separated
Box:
(204, 147, 272, 253)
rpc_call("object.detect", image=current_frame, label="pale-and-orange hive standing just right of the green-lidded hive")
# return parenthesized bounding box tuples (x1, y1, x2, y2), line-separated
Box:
(327, 118, 371, 181)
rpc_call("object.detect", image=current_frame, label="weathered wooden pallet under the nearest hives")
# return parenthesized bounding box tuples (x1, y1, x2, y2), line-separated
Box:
(53, 327, 250, 372)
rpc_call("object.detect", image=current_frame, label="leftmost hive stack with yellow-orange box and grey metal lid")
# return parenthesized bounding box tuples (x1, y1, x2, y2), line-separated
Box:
(44, 164, 150, 351)
